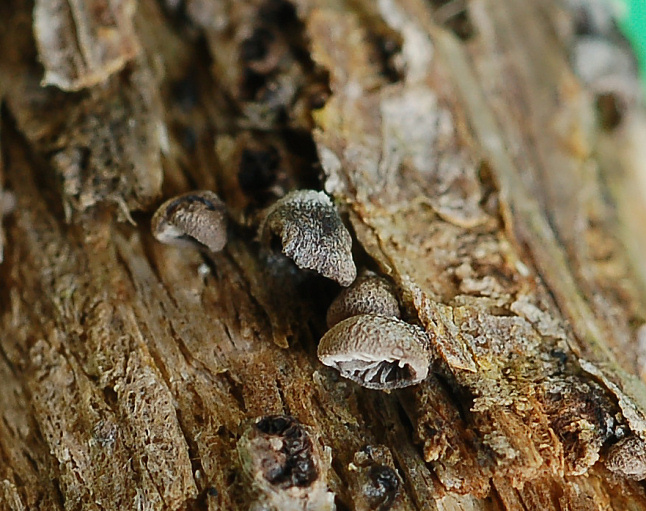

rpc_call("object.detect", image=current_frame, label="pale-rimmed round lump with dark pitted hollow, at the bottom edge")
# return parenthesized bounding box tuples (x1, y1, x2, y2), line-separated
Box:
(237, 415, 334, 511)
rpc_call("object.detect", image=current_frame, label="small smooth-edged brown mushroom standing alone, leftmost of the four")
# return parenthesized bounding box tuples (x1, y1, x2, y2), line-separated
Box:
(151, 190, 227, 252)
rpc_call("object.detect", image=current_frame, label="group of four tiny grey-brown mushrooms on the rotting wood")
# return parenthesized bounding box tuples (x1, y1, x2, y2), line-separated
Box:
(151, 190, 431, 390)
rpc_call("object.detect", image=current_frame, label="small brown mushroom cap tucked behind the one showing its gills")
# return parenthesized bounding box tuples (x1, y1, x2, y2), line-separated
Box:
(327, 271, 400, 328)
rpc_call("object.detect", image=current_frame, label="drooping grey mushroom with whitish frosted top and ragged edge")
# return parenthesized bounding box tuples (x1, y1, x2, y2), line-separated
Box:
(260, 190, 357, 286)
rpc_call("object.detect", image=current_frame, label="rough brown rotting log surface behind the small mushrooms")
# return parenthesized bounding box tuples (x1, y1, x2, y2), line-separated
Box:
(0, 0, 646, 510)
